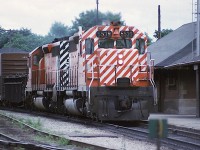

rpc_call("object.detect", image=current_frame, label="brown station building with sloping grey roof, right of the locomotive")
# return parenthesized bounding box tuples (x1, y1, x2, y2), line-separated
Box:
(148, 22, 200, 116)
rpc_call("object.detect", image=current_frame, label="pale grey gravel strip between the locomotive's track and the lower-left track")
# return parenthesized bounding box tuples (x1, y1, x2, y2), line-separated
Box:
(0, 110, 168, 150)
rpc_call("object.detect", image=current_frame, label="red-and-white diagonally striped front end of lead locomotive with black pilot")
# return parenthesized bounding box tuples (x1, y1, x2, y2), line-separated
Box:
(82, 23, 155, 121)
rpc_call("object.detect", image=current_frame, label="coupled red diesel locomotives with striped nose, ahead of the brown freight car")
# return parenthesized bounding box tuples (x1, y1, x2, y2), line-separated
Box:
(25, 22, 156, 121)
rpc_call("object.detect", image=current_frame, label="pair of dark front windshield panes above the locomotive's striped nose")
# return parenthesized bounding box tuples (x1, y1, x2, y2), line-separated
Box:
(98, 39, 132, 49)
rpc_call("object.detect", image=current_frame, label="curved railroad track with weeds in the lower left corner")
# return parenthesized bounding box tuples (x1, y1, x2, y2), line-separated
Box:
(0, 110, 111, 150)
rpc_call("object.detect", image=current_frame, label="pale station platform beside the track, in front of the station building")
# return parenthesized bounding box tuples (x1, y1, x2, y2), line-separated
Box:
(149, 114, 200, 130)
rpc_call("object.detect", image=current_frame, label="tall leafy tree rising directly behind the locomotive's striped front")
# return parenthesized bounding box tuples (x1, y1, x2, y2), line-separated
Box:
(71, 10, 124, 32)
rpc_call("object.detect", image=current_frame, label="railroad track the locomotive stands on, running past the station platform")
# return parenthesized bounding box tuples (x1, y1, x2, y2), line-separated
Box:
(1, 108, 200, 150)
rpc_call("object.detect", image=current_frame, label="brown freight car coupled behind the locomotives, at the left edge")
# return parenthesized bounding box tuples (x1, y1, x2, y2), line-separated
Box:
(0, 48, 28, 106)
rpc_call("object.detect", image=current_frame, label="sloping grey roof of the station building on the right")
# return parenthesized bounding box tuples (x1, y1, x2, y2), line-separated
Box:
(148, 22, 200, 67)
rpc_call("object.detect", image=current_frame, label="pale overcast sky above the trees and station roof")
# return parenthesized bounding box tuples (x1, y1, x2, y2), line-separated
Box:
(0, 0, 195, 37)
